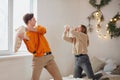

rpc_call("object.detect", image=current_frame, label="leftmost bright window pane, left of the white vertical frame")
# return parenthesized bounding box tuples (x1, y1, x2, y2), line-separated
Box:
(0, 0, 8, 50)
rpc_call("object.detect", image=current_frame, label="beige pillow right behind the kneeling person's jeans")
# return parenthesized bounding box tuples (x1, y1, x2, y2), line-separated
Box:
(90, 56, 106, 73)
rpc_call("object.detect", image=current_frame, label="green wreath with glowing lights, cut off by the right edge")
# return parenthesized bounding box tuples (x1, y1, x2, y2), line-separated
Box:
(107, 13, 120, 38)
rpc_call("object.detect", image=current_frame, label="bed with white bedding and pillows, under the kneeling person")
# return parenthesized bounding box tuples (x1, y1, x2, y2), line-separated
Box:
(50, 56, 120, 80)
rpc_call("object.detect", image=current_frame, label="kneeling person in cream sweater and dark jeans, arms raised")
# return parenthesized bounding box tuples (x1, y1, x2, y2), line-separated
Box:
(63, 25, 102, 80)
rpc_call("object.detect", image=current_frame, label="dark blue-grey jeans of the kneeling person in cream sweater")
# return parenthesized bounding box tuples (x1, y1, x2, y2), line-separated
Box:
(74, 54, 102, 80)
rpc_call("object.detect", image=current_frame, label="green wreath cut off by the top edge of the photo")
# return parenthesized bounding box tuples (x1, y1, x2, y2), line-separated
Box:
(89, 0, 111, 9)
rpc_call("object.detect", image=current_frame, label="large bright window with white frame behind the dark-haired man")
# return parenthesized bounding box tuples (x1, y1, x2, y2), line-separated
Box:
(0, 0, 37, 54)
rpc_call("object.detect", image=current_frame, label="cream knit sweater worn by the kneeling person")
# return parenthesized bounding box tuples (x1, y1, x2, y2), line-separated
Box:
(63, 29, 89, 55)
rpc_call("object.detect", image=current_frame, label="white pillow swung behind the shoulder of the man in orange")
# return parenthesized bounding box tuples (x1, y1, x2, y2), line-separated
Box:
(14, 26, 29, 52)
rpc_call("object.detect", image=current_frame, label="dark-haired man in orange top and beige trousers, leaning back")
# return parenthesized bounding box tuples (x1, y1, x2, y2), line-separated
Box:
(19, 13, 62, 80)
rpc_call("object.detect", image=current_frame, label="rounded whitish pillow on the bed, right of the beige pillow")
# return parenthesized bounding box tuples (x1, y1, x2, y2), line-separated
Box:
(103, 59, 117, 72)
